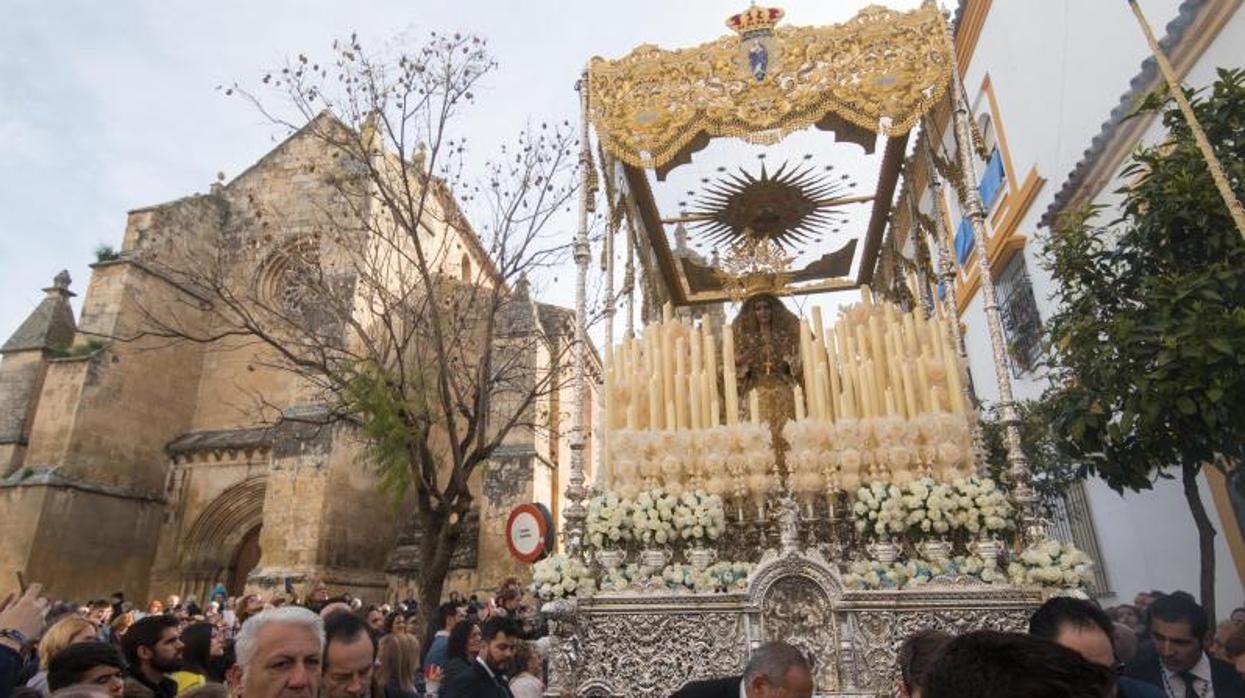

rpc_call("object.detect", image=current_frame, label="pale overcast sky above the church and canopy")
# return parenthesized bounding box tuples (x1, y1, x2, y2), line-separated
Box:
(0, 0, 918, 342)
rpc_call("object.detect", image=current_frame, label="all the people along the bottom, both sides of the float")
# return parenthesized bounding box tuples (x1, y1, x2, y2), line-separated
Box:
(0, 580, 1245, 698)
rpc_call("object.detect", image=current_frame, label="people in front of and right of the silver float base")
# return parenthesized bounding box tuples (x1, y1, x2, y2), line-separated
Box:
(672, 591, 1245, 698)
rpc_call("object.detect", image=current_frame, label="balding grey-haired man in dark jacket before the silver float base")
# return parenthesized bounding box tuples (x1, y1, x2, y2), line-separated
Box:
(670, 642, 813, 698)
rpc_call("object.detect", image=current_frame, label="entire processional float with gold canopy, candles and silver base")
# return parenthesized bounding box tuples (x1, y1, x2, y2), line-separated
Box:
(545, 1, 1089, 697)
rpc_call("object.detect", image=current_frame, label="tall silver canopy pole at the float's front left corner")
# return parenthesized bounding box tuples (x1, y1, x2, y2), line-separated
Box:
(563, 71, 595, 555)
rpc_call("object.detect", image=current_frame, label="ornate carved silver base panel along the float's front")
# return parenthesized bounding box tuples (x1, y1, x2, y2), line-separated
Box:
(555, 550, 1041, 698)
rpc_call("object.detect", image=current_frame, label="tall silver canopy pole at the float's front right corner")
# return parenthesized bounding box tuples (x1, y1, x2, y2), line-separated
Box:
(951, 58, 1046, 541)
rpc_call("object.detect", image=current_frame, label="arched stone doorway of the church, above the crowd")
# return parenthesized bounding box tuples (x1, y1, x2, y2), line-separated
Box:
(179, 475, 266, 601)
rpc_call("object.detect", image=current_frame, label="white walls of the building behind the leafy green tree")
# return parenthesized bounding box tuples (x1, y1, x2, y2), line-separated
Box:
(949, 0, 1245, 610)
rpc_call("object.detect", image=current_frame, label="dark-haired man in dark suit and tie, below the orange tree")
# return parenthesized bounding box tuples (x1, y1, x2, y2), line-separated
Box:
(1127, 591, 1245, 698)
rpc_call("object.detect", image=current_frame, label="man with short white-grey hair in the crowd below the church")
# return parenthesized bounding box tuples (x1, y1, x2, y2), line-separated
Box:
(227, 606, 324, 698)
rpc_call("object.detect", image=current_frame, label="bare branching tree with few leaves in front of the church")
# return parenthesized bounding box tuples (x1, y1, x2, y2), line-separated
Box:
(110, 34, 581, 613)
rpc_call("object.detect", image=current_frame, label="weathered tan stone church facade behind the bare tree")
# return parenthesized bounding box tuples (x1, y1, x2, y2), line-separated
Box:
(0, 117, 599, 600)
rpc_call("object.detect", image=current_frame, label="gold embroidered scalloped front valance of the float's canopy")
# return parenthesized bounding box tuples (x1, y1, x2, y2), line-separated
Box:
(588, 0, 951, 168)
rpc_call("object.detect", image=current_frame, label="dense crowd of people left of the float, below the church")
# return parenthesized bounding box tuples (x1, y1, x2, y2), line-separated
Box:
(0, 580, 548, 698)
